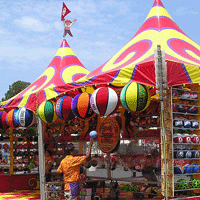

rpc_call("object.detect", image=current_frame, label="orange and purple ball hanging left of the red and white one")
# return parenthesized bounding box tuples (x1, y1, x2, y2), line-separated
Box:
(72, 92, 94, 119)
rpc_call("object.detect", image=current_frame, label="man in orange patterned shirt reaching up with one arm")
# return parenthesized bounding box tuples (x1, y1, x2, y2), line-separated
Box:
(57, 138, 94, 200)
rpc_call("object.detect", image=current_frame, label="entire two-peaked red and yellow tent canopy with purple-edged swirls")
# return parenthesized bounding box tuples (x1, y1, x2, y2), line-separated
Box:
(1, 0, 200, 110)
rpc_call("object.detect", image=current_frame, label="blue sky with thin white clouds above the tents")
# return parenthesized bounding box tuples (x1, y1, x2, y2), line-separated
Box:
(0, 0, 200, 99)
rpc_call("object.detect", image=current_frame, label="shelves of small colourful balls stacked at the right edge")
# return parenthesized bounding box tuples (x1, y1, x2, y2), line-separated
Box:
(172, 86, 200, 195)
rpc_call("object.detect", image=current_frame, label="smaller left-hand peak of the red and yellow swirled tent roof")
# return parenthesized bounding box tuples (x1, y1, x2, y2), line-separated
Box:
(0, 39, 89, 111)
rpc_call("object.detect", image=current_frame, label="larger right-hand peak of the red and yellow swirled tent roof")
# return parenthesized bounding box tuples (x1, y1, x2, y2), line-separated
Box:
(68, 0, 200, 86)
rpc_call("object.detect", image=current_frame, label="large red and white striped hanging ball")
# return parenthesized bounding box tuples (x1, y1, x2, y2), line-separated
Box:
(90, 87, 118, 116)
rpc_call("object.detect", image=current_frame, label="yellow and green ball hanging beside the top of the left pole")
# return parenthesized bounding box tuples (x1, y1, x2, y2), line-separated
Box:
(38, 101, 58, 123)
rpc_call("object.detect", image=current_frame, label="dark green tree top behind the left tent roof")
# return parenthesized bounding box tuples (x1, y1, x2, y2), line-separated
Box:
(2, 81, 31, 101)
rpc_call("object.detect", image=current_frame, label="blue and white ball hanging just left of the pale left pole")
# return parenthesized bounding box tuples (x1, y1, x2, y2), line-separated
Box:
(15, 107, 35, 127)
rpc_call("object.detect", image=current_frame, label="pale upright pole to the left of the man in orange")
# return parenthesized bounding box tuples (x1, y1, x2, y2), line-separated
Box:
(37, 115, 45, 200)
